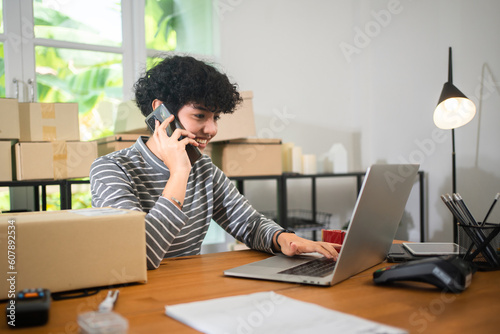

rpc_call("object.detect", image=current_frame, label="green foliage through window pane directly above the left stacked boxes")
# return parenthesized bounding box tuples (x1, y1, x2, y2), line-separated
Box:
(35, 46, 123, 140)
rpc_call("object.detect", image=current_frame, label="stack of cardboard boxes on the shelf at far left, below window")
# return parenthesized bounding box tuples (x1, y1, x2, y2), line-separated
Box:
(0, 99, 97, 181)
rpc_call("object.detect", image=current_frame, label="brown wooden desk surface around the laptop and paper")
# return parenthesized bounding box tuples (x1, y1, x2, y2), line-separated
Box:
(0, 250, 500, 334)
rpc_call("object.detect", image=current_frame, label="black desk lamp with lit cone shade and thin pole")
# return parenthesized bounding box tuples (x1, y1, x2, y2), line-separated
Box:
(434, 47, 476, 242)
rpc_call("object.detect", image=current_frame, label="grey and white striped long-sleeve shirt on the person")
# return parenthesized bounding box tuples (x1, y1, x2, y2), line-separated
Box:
(90, 137, 282, 269)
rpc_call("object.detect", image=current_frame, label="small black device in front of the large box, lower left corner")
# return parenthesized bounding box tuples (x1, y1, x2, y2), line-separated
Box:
(5, 289, 50, 328)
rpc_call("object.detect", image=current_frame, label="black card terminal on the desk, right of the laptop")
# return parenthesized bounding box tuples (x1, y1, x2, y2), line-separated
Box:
(373, 255, 475, 293)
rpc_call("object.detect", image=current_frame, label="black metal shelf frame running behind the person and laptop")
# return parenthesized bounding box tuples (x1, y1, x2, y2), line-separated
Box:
(0, 171, 426, 242)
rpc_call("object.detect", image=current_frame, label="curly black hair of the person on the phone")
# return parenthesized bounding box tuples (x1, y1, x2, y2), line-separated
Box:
(134, 55, 242, 116)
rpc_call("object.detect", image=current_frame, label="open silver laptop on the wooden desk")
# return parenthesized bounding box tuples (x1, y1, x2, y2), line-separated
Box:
(224, 164, 419, 286)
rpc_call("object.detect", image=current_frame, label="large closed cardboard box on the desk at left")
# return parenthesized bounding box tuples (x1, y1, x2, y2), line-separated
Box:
(0, 208, 147, 299)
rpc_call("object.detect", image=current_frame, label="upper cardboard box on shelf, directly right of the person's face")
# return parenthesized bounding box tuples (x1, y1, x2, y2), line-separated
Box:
(211, 91, 257, 142)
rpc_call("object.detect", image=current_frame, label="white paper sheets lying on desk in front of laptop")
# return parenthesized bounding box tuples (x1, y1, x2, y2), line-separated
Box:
(165, 291, 407, 334)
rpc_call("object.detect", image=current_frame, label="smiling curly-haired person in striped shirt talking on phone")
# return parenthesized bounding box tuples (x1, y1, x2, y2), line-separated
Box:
(90, 56, 337, 269)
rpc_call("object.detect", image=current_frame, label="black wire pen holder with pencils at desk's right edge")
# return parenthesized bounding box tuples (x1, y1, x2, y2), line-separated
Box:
(441, 193, 500, 270)
